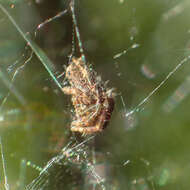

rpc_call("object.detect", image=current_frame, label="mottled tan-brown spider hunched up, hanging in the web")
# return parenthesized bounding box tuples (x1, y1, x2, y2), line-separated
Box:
(62, 57, 115, 134)
